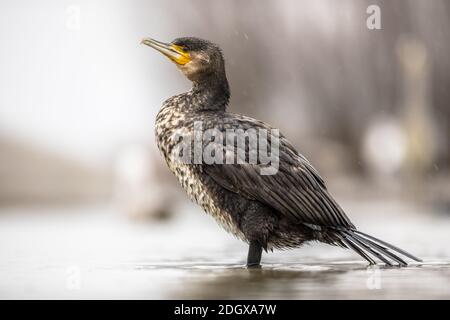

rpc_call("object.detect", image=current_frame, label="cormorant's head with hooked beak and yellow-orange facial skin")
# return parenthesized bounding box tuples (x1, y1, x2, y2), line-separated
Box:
(141, 37, 225, 82)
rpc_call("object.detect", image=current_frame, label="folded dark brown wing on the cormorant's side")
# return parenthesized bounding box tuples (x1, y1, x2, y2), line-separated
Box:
(202, 115, 355, 229)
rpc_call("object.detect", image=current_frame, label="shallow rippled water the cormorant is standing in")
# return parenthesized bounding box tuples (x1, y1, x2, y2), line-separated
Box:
(0, 204, 450, 299)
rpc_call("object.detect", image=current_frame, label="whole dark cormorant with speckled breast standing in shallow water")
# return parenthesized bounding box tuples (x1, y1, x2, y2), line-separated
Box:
(141, 37, 422, 268)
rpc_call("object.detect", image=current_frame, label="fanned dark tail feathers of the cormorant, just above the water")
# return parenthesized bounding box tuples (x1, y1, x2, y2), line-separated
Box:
(336, 230, 422, 266)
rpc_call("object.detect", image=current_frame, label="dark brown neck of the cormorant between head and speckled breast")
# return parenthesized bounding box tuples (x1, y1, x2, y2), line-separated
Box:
(191, 73, 230, 111)
